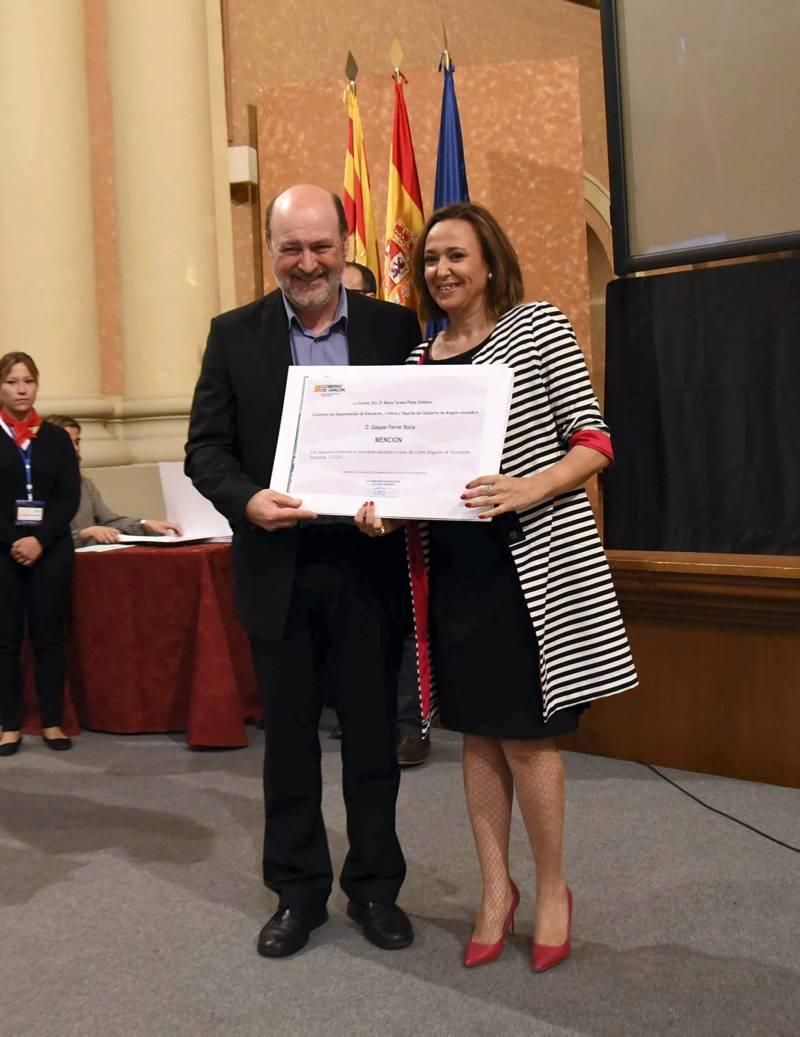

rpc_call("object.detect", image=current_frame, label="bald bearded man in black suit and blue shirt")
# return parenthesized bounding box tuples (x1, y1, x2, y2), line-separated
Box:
(186, 185, 420, 957)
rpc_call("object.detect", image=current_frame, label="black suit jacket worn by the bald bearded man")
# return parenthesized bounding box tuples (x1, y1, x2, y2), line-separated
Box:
(186, 291, 421, 639)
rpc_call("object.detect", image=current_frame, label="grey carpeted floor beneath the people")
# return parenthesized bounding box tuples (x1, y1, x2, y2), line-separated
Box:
(0, 731, 800, 1037)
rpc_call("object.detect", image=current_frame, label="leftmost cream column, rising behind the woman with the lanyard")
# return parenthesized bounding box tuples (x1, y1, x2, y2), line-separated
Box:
(0, 0, 128, 464)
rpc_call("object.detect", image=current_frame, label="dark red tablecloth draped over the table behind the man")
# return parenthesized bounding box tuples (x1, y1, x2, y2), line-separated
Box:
(25, 543, 260, 749)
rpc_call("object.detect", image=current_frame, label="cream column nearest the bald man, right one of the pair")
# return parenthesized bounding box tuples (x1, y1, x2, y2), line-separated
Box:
(108, 0, 229, 461)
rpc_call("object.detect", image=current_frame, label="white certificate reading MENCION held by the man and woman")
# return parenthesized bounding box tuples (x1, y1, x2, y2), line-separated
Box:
(270, 364, 514, 521)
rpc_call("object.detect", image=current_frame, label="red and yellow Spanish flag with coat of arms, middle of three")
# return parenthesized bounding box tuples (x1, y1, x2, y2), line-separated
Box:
(383, 72, 425, 307)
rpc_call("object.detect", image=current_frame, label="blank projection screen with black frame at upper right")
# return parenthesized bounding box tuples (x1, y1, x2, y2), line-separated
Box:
(601, 0, 800, 274)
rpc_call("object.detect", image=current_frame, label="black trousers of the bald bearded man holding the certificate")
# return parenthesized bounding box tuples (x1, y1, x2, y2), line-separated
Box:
(252, 524, 406, 909)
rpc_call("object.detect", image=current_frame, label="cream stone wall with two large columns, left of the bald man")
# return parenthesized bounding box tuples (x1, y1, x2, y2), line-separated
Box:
(0, 0, 235, 465)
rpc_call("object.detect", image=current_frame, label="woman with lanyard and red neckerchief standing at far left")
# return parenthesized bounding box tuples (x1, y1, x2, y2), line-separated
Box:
(0, 353, 81, 757)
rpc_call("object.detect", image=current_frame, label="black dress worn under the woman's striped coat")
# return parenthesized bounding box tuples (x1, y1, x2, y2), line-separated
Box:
(425, 343, 581, 738)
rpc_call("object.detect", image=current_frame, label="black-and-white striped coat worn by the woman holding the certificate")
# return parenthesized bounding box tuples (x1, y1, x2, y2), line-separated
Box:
(407, 302, 637, 719)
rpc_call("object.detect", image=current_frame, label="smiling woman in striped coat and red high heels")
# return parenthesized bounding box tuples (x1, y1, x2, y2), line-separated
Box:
(356, 204, 636, 972)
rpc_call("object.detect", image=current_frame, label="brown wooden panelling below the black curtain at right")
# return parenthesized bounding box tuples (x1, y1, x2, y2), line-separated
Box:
(560, 551, 800, 788)
